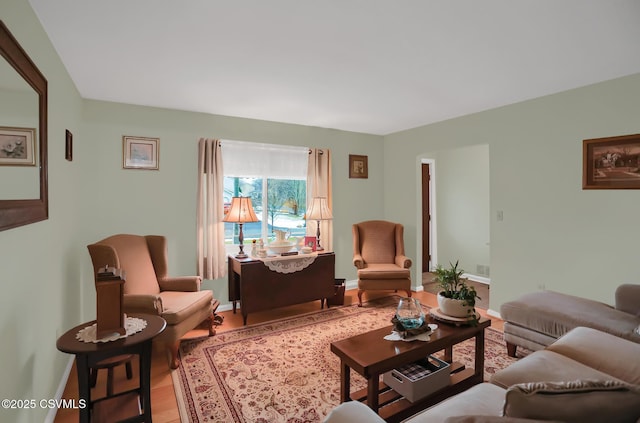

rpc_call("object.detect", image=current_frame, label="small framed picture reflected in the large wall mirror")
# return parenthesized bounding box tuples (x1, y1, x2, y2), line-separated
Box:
(0, 126, 36, 166)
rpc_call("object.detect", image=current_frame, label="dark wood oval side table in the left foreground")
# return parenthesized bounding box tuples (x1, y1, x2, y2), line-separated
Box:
(56, 313, 167, 423)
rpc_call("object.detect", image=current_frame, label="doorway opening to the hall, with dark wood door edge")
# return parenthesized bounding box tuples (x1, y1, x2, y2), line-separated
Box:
(418, 144, 490, 308)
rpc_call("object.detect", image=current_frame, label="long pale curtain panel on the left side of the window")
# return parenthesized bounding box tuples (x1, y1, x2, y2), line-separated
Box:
(196, 138, 227, 279)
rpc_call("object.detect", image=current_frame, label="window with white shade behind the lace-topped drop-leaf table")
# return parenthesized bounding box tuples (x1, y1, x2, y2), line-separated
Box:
(222, 140, 309, 245)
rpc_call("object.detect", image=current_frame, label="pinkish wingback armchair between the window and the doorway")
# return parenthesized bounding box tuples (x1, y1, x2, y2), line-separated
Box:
(352, 220, 411, 307)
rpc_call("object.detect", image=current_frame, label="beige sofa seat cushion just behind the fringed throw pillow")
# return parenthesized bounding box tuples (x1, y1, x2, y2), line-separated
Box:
(491, 350, 617, 389)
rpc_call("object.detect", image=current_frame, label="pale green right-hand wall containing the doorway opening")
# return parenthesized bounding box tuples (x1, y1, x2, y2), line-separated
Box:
(384, 74, 640, 311)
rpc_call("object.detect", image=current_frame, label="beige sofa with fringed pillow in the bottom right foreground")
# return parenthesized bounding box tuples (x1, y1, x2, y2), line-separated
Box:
(325, 327, 640, 423)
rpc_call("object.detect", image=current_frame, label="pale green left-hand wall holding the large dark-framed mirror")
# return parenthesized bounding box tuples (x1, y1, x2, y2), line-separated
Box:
(0, 0, 86, 422)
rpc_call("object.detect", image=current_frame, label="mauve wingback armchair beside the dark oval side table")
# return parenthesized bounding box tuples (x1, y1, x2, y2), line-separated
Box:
(87, 234, 220, 369)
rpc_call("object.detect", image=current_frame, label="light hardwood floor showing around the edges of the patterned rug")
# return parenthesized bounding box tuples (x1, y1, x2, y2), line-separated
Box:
(55, 290, 502, 423)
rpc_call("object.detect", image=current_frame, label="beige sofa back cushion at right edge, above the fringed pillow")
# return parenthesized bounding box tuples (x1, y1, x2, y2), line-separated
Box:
(547, 327, 640, 385)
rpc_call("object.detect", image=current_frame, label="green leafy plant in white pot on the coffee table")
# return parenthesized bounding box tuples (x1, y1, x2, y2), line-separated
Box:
(434, 261, 481, 323)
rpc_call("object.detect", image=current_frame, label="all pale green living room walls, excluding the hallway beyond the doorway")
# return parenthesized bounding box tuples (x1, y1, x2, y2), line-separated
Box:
(0, 0, 640, 422)
